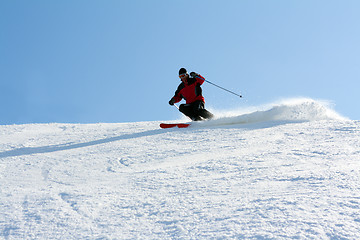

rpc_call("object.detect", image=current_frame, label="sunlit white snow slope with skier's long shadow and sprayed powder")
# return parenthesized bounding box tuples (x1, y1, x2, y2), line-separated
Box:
(0, 99, 360, 239)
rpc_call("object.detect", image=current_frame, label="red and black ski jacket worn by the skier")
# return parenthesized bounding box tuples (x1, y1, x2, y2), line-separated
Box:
(173, 74, 205, 104)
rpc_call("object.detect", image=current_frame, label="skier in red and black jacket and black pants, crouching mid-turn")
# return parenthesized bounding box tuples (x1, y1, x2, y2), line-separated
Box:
(169, 68, 214, 121)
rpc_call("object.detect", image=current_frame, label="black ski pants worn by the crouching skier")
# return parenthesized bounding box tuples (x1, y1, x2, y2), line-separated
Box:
(179, 100, 214, 121)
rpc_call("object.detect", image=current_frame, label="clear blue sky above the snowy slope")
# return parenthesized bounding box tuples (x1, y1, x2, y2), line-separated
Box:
(0, 0, 360, 124)
